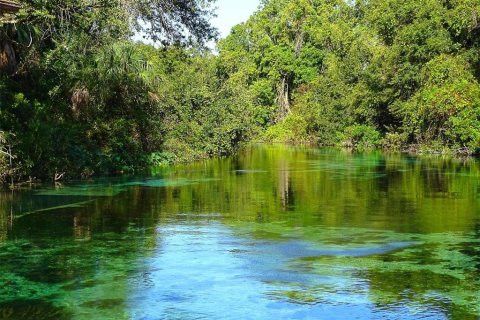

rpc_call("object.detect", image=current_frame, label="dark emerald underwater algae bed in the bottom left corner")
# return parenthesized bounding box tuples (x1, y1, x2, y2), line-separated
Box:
(0, 228, 154, 319)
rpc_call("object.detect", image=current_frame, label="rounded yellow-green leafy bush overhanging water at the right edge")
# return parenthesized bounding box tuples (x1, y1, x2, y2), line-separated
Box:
(403, 55, 480, 150)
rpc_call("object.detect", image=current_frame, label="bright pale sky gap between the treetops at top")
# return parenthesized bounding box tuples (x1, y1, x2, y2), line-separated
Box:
(212, 0, 260, 38)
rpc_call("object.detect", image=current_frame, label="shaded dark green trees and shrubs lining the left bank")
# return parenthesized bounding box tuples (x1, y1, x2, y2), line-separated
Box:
(0, 0, 254, 180)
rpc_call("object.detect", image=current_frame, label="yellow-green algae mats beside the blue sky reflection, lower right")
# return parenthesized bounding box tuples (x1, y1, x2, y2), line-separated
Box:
(230, 222, 480, 319)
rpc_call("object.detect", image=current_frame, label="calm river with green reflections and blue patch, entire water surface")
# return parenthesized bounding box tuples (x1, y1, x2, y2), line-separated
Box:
(0, 146, 480, 320)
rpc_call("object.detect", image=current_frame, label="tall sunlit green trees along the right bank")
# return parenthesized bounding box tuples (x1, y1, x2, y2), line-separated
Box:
(219, 0, 480, 152)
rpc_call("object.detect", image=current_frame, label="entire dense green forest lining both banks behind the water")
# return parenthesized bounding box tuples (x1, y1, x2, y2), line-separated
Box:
(0, 0, 480, 181)
